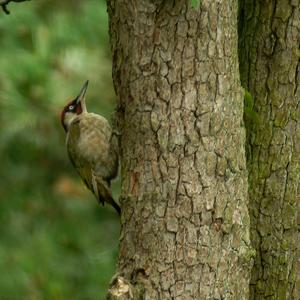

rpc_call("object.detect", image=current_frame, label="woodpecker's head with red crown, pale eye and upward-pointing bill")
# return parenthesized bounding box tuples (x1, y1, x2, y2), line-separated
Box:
(61, 80, 89, 131)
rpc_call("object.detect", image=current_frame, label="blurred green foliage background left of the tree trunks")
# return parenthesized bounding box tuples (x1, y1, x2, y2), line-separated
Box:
(0, 0, 119, 300)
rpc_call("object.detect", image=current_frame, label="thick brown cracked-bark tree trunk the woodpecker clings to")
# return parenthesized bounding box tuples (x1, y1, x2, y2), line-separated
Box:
(108, 0, 253, 300)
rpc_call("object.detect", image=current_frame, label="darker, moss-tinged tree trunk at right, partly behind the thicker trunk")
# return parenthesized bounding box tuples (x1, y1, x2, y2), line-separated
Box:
(239, 0, 300, 300)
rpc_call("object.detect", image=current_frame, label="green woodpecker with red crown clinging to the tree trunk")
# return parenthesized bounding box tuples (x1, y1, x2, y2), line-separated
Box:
(61, 81, 121, 214)
